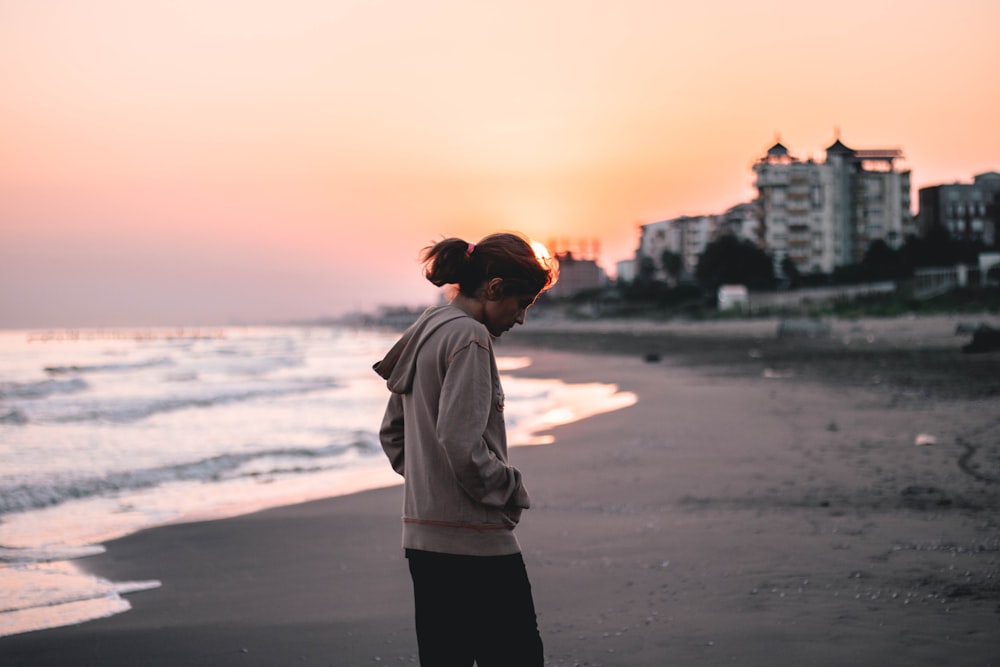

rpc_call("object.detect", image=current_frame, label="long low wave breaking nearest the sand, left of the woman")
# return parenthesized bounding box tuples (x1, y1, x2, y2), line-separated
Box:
(0, 431, 381, 515)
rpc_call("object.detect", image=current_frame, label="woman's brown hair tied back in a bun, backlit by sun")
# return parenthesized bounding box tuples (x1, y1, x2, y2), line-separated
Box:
(421, 232, 559, 296)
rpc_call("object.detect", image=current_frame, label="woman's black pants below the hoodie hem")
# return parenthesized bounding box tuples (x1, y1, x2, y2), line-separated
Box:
(406, 549, 544, 667)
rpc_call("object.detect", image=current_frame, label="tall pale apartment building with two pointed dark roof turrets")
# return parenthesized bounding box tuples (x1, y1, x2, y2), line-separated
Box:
(753, 139, 914, 273)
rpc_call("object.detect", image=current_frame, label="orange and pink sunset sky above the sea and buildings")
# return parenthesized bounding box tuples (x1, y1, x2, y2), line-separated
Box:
(0, 0, 1000, 328)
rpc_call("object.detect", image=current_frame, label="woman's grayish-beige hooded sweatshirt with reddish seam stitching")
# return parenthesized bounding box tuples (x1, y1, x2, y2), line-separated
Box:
(375, 305, 530, 556)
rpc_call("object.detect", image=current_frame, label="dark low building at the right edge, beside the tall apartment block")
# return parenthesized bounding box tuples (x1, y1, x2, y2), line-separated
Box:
(917, 172, 1000, 246)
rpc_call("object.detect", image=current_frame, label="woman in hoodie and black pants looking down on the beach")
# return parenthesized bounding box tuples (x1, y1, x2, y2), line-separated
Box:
(375, 233, 557, 667)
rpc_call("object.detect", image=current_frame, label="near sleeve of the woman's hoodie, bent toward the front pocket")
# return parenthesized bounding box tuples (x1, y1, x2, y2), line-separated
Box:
(437, 342, 529, 508)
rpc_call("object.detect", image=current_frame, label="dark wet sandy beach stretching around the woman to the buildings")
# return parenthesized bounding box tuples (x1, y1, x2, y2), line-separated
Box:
(0, 317, 1000, 666)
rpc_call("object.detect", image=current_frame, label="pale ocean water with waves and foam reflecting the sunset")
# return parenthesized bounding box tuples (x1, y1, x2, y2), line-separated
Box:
(0, 326, 636, 637)
